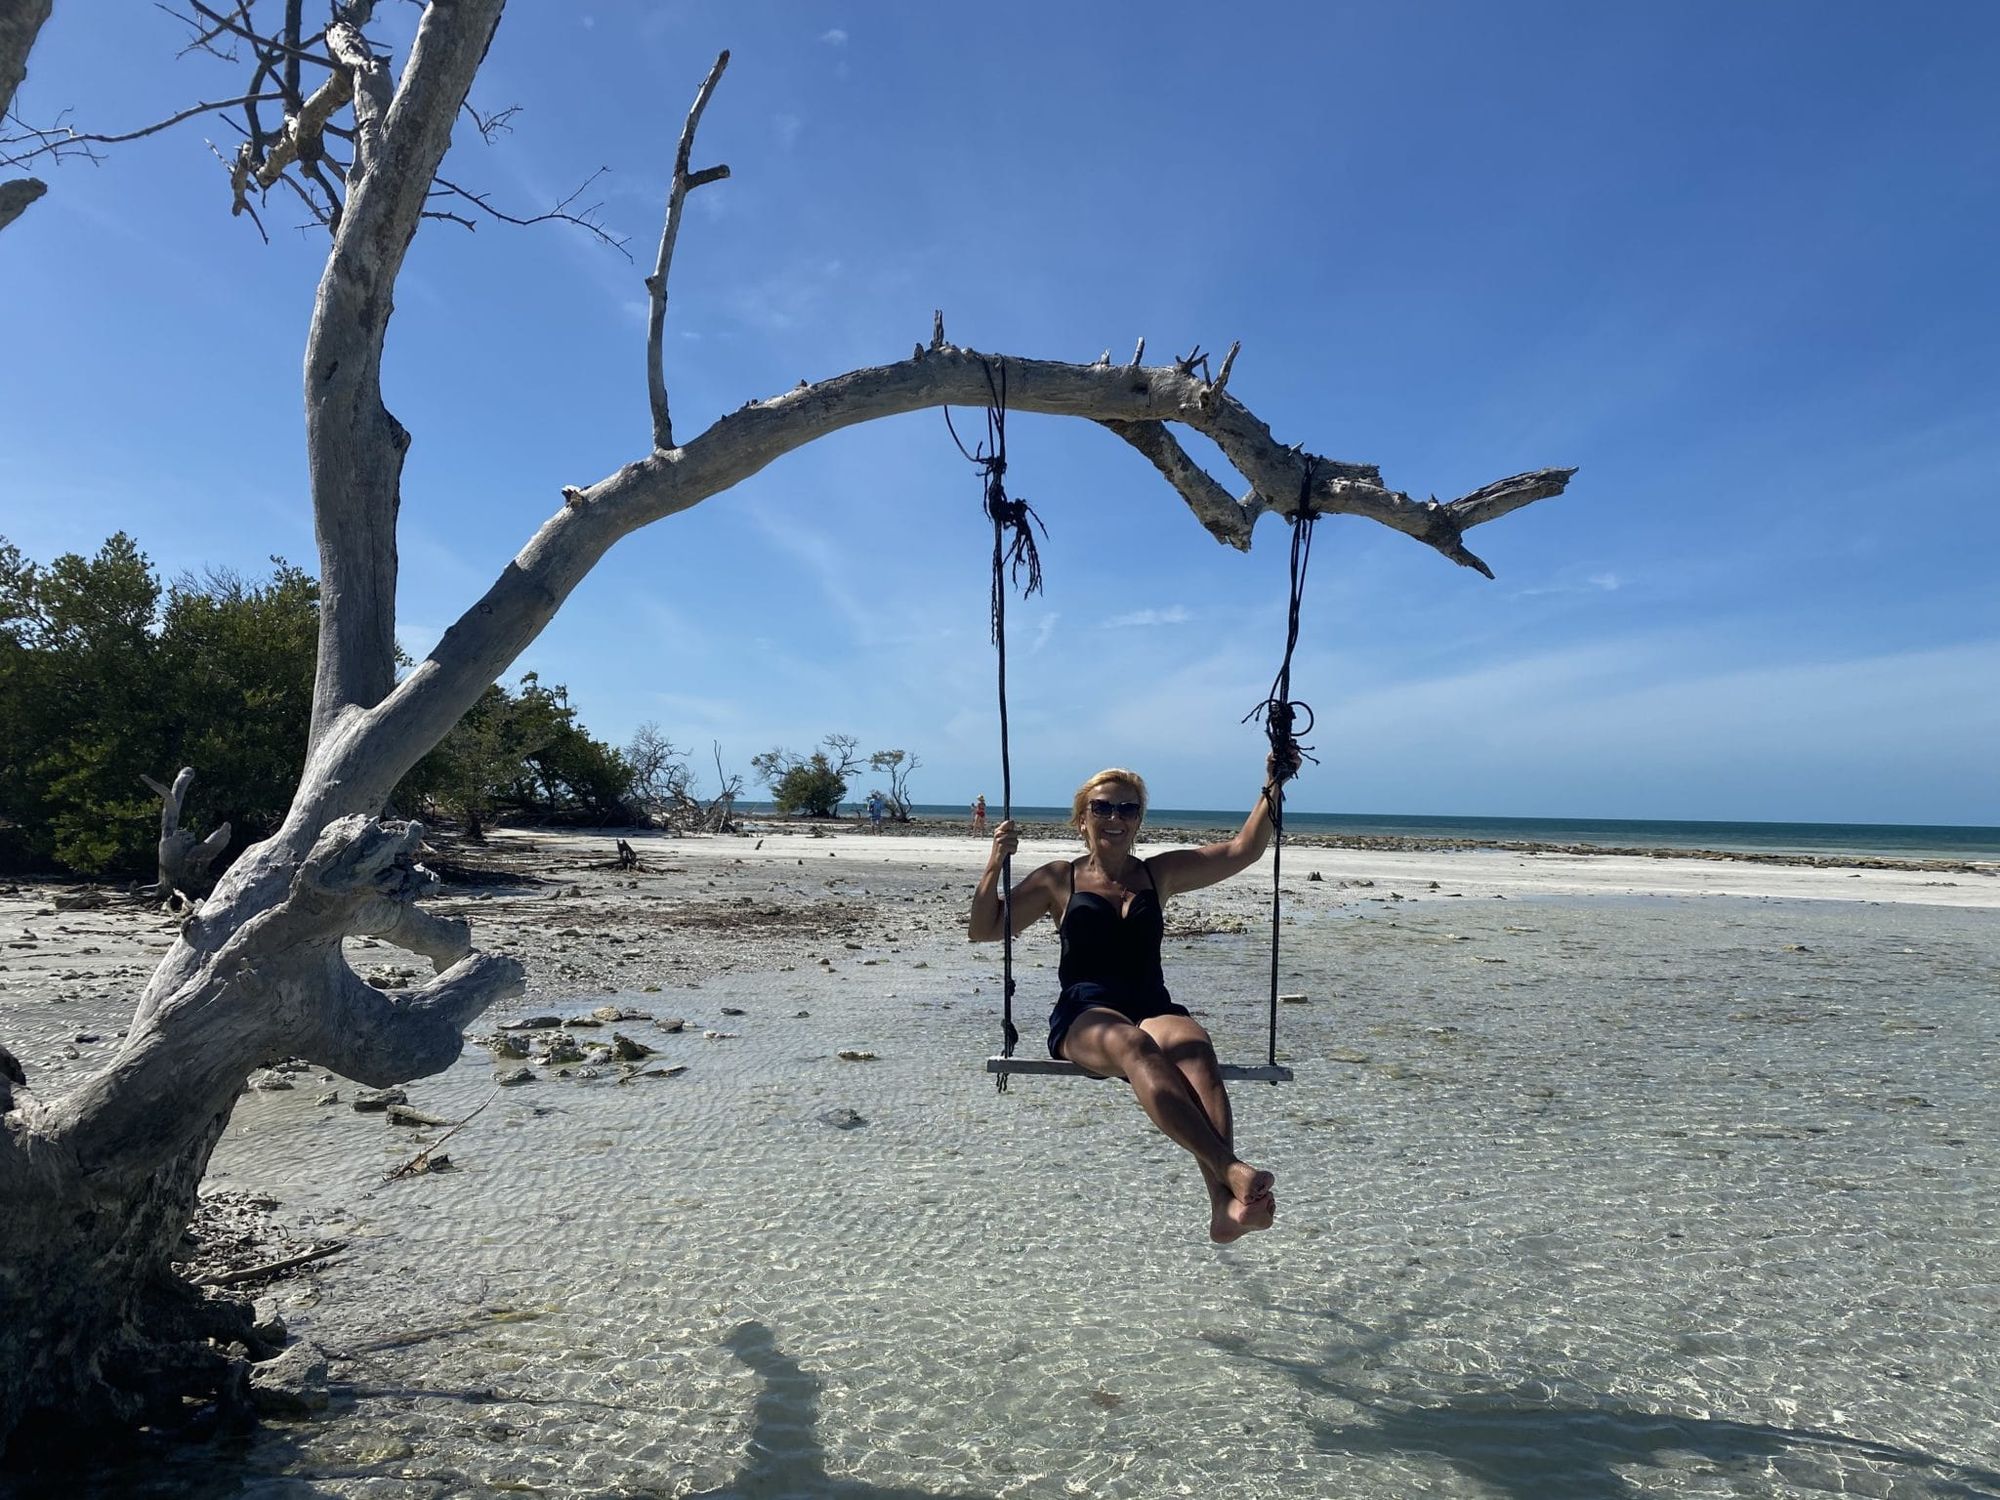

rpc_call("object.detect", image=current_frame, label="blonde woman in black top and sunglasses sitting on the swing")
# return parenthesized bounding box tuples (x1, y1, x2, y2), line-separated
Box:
(966, 754, 1298, 1244)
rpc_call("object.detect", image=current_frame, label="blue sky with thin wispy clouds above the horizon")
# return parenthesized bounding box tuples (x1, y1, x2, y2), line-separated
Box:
(0, 2, 2000, 824)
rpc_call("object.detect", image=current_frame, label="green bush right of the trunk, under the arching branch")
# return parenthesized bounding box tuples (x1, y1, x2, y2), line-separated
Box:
(396, 672, 640, 840)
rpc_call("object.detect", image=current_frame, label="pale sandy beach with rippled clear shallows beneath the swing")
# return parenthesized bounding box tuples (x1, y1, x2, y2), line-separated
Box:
(0, 824, 2000, 1500)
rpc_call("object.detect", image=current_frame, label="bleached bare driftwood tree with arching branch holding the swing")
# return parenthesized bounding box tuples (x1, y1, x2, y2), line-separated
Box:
(0, 0, 1570, 1440)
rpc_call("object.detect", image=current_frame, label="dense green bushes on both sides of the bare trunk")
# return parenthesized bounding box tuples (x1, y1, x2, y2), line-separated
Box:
(0, 532, 640, 876)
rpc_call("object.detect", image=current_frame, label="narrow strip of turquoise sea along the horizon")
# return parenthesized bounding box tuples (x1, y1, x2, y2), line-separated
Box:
(788, 804, 2000, 860)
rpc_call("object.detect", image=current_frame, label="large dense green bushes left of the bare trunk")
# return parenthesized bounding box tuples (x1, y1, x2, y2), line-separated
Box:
(0, 532, 320, 874)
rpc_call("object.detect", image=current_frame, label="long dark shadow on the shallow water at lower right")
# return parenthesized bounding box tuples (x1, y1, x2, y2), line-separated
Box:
(1202, 1332, 2000, 1500)
